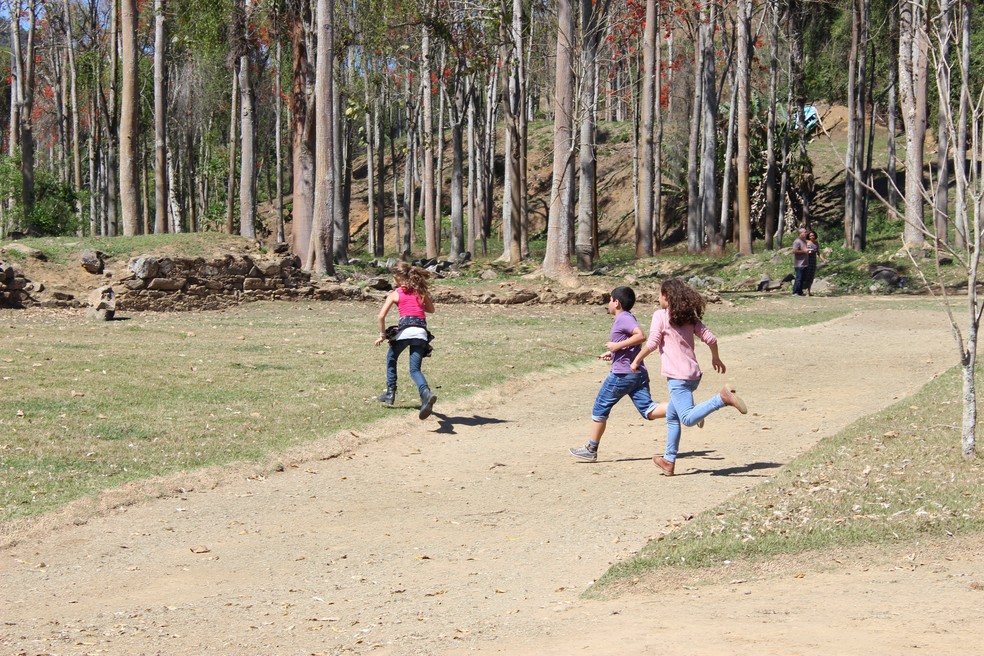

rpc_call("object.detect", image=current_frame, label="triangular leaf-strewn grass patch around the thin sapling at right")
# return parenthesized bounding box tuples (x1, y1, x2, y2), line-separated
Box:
(588, 368, 984, 595)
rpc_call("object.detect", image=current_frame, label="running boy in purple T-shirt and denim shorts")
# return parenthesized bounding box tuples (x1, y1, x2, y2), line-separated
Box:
(570, 287, 666, 462)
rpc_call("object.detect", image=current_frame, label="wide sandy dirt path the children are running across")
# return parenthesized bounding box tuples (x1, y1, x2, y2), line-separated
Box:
(0, 307, 984, 656)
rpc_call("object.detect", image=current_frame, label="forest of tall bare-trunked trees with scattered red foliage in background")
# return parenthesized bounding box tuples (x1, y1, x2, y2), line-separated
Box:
(0, 0, 984, 270)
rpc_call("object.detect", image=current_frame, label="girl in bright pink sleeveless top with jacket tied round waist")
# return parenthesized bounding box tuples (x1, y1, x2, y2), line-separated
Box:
(376, 262, 437, 419)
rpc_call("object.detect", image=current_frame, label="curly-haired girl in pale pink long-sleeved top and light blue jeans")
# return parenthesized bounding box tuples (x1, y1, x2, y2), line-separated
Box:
(632, 278, 748, 476)
